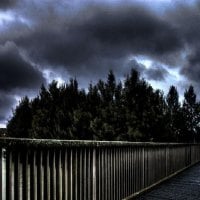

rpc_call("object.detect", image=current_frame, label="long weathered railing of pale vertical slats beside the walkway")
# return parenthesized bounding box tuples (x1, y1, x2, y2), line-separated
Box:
(0, 138, 200, 200)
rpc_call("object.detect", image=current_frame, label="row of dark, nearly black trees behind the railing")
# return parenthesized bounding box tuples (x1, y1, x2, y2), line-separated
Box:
(7, 69, 200, 142)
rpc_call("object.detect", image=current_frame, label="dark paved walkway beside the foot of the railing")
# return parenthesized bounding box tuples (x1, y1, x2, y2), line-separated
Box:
(136, 164, 200, 200)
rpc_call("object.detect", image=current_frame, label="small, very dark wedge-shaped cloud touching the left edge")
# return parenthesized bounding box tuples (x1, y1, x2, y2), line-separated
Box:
(0, 42, 45, 92)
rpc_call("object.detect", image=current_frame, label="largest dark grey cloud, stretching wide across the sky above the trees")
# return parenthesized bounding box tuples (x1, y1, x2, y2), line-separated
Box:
(7, 6, 182, 71)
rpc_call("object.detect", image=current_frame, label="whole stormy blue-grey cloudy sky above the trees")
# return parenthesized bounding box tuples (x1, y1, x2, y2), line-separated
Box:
(0, 0, 200, 126)
